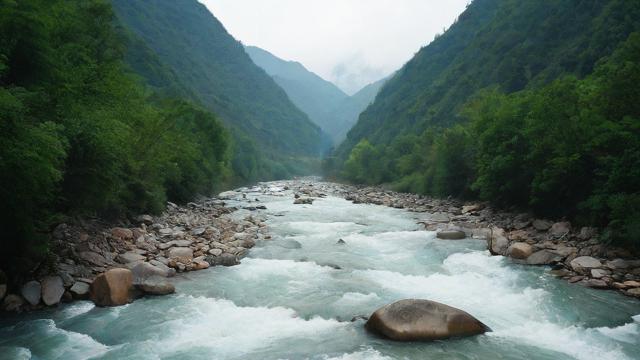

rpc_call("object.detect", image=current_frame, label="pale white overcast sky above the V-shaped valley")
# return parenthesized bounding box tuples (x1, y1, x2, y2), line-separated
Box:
(199, 0, 469, 94)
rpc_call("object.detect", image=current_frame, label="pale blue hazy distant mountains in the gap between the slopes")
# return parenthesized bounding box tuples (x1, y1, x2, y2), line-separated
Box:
(245, 46, 384, 144)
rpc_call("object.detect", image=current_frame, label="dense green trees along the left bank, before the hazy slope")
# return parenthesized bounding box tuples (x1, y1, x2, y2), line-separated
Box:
(0, 0, 230, 272)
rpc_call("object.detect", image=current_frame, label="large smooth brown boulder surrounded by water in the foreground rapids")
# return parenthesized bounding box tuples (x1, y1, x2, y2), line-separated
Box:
(365, 299, 491, 341)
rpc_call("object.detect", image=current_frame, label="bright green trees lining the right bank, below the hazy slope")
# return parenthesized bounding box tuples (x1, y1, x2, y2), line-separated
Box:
(343, 33, 640, 247)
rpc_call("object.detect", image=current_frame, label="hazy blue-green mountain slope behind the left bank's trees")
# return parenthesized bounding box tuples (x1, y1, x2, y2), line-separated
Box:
(112, 0, 328, 180)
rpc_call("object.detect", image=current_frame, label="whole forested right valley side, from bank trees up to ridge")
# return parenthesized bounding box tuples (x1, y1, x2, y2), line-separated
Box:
(336, 0, 640, 245)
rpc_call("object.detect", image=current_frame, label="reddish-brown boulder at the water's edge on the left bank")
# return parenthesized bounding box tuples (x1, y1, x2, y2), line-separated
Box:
(90, 269, 133, 306)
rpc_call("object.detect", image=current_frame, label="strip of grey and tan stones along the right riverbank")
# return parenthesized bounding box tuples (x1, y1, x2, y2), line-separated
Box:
(282, 181, 640, 298)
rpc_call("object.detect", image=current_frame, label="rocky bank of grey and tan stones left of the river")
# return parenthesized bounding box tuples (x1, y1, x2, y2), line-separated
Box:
(0, 198, 269, 312)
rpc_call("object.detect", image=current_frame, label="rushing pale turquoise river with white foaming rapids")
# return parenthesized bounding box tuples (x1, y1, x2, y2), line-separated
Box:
(0, 184, 640, 360)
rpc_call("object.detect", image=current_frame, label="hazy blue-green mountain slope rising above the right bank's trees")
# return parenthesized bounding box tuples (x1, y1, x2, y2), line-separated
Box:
(338, 0, 639, 159)
